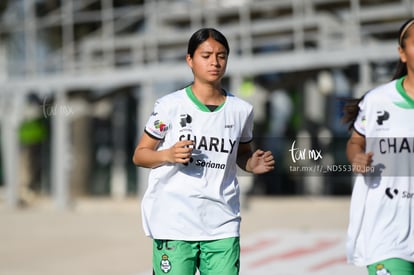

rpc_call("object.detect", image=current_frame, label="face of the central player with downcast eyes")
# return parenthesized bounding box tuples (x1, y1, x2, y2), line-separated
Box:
(186, 37, 227, 83)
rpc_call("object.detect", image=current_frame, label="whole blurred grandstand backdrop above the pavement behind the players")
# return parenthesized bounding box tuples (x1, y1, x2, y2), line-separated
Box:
(0, 0, 414, 208)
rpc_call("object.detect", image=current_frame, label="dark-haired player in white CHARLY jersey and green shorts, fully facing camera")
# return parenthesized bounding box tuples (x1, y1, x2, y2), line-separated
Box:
(133, 28, 275, 275)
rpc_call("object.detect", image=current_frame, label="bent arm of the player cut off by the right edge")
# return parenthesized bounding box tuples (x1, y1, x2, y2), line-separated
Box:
(346, 131, 373, 173)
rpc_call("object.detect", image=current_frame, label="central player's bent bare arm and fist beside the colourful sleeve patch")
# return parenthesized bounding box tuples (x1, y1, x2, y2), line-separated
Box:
(132, 132, 193, 168)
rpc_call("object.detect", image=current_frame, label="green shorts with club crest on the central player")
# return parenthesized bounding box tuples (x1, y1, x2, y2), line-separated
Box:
(152, 237, 240, 275)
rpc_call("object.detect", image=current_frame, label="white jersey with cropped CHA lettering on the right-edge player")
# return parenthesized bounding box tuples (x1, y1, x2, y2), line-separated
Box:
(347, 78, 414, 266)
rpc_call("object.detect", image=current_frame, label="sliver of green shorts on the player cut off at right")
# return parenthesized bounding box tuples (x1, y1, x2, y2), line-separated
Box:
(368, 258, 414, 275)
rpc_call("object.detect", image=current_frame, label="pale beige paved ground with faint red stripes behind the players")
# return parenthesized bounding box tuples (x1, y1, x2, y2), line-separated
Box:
(0, 197, 365, 275)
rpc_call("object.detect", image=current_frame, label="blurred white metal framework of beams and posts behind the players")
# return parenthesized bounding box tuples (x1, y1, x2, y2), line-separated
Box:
(0, 0, 414, 208)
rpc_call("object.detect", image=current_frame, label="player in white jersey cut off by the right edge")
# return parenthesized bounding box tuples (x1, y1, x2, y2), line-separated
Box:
(345, 18, 414, 275)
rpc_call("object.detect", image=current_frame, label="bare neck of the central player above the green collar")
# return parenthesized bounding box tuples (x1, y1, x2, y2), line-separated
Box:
(191, 83, 226, 106)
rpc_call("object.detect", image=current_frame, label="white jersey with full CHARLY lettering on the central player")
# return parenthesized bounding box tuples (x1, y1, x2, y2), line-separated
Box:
(142, 87, 253, 241)
